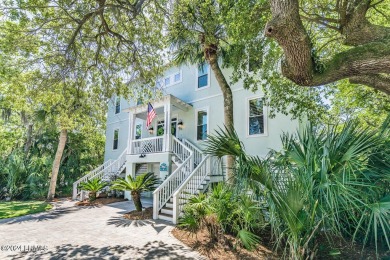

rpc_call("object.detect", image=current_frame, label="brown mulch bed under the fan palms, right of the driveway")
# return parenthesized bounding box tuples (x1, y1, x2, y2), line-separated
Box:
(172, 228, 279, 260)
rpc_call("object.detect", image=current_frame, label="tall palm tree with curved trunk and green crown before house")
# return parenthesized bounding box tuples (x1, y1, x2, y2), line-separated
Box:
(168, 0, 234, 177)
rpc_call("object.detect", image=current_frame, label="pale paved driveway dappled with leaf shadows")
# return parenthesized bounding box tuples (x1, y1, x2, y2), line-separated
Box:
(0, 198, 202, 259)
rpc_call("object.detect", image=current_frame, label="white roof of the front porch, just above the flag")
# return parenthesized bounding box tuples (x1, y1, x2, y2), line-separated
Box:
(123, 95, 192, 119)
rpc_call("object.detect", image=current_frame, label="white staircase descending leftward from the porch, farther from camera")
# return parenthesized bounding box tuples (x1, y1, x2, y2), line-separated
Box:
(72, 149, 127, 200)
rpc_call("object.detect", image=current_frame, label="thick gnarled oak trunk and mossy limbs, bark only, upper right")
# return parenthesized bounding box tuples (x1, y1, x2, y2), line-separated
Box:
(264, 0, 390, 95)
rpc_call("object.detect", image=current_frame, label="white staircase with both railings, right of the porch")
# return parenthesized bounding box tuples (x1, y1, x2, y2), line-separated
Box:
(153, 137, 219, 224)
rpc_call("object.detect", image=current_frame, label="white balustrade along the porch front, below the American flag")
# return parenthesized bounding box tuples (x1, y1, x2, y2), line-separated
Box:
(130, 136, 164, 154)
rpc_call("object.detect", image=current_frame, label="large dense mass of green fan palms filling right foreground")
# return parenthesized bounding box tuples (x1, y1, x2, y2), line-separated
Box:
(206, 121, 390, 259)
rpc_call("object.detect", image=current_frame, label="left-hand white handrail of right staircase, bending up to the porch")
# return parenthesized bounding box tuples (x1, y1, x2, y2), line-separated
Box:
(153, 137, 194, 219)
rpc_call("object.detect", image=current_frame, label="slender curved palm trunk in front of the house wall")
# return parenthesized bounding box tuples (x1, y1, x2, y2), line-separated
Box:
(208, 53, 234, 180)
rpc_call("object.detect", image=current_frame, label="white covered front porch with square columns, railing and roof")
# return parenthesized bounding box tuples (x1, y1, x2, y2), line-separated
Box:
(125, 95, 191, 154)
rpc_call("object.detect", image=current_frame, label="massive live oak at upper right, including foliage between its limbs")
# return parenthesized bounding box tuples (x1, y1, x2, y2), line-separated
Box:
(264, 0, 390, 94)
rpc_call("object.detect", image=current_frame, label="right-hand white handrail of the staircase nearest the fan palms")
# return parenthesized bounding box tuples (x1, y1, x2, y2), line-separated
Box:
(172, 155, 212, 224)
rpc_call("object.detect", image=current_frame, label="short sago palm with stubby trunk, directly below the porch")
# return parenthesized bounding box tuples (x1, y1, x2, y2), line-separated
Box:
(111, 172, 159, 211)
